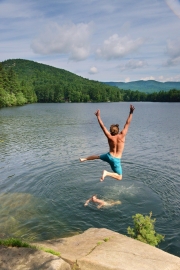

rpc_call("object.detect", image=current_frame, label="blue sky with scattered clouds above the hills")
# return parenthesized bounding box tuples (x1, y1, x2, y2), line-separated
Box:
(0, 0, 180, 82)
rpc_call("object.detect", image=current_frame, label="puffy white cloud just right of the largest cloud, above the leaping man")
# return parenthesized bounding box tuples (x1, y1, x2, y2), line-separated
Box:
(96, 34, 144, 60)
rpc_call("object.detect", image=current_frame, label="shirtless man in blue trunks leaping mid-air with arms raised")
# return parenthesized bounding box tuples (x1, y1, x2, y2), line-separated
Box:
(80, 105, 135, 181)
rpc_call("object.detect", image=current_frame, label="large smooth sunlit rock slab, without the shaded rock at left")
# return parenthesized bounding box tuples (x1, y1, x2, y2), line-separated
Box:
(36, 228, 180, 270)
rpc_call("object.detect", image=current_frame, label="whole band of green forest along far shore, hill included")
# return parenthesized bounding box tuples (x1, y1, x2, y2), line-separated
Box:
(0, 59, 180, 108)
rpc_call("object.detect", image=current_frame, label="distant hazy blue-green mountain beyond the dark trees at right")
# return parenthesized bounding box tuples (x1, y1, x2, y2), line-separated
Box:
(105, 80, 180, 93)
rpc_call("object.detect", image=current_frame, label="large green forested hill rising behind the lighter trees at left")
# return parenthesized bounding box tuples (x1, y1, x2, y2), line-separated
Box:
(2, 59, 122, 102)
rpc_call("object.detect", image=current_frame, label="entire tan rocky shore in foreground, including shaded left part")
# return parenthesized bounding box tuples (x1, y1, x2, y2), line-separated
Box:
(0, 228, 180, 270)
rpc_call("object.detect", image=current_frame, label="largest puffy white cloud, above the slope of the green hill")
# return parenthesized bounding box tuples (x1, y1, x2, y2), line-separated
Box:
(31, 23, 92, 61)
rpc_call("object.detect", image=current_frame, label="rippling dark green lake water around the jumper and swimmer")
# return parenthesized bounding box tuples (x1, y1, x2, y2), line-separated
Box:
(0, 102, 180, 256)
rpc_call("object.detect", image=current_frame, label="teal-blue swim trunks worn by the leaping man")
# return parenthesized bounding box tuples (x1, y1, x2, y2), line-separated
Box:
(99, 153, 122, 175)
